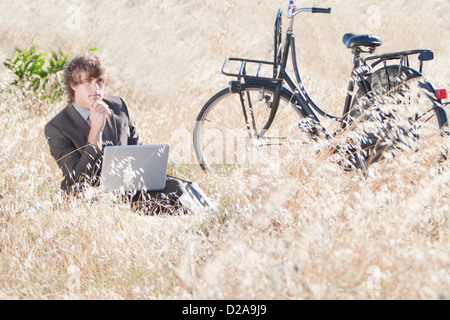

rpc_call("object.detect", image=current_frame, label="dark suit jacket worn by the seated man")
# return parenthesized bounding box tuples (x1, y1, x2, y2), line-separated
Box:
(45, 97, 142, 191)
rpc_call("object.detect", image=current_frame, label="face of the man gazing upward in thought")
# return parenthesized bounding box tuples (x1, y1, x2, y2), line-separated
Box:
(71, 72, 104, 109)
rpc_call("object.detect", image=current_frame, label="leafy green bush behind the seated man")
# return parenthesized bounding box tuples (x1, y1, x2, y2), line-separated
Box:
(3, 45, 68, 100)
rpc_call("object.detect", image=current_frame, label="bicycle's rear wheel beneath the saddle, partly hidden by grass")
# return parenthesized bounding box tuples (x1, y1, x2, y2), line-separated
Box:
(349, 65, 448, 164)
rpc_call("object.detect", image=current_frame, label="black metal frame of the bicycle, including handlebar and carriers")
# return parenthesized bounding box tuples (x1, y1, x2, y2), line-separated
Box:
(222, 1, 442, 139)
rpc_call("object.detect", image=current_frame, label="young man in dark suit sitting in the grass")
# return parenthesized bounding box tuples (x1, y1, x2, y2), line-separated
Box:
(45, 54, 199, 213)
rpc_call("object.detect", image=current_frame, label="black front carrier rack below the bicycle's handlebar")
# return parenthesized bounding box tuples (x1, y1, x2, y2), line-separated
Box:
(222, 58, 277, 81)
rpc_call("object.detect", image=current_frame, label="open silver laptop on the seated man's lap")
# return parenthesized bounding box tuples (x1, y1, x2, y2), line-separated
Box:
(100, 144, 170, 192)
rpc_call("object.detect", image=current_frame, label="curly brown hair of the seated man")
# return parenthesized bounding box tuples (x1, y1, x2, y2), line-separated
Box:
(64, 53, 108, 103)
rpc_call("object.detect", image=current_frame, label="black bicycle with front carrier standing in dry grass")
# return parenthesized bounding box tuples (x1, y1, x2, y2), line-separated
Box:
(193, 0, 448, 174)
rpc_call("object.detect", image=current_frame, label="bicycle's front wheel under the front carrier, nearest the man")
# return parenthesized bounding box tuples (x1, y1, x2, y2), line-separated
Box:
(194, 83, 305, 175)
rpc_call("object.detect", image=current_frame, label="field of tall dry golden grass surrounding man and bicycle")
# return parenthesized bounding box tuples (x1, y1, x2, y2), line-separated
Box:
(0, 0, 450, 299)
